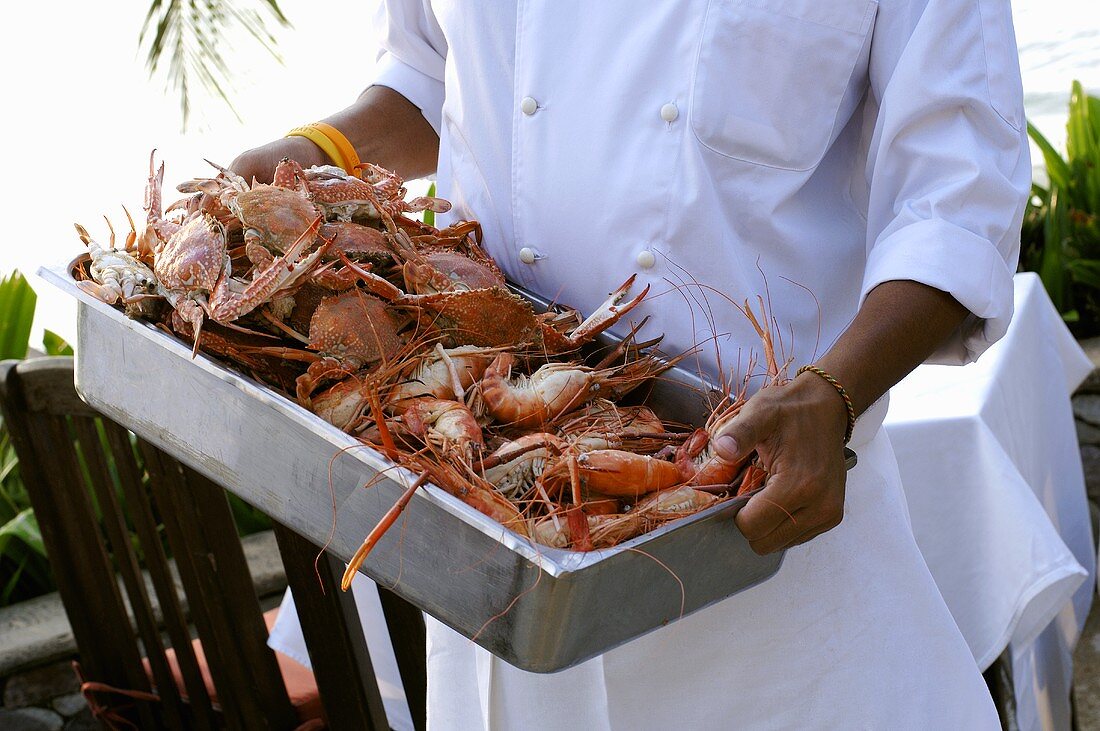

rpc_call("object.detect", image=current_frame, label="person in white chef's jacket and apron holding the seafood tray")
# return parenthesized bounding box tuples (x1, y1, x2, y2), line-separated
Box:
(233, 0, 1031, 729)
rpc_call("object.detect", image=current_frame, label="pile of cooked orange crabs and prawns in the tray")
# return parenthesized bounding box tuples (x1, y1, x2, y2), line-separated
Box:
(73, 157, 780, 575)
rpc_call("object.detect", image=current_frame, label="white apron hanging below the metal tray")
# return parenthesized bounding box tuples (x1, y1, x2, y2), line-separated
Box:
(428, 406, 1000, 731)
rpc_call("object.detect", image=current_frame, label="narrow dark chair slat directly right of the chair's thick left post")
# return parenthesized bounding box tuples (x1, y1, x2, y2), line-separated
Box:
(73, 417, 184, 728)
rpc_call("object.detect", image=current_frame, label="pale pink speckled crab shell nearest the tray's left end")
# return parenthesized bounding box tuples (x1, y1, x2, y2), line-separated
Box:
(153, 212, 227, 291)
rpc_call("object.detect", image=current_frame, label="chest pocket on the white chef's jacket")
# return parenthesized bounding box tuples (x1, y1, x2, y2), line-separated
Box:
(691, 0, 878, 170)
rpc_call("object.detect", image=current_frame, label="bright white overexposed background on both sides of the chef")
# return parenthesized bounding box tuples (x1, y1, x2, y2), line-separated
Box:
(0, 0, 1100, 341)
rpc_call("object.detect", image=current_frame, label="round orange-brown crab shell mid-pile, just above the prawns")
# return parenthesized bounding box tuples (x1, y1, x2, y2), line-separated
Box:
(309, 289, 404, 367)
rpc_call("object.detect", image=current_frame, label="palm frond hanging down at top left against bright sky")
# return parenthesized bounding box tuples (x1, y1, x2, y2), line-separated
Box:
(139, 0, 290, 128)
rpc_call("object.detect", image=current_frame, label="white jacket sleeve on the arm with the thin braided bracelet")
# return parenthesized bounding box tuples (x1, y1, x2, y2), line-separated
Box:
(861, 0, 1031, 363)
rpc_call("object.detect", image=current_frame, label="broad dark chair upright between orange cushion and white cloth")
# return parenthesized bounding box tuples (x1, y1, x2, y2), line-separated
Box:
(274, 522, 389, 731)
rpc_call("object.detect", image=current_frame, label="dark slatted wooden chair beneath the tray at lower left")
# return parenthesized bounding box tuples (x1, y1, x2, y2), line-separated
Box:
(0, 357, 425, 730)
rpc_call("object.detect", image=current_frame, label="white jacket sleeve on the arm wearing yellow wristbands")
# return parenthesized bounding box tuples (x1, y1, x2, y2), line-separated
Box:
(372, 0, 447, 134)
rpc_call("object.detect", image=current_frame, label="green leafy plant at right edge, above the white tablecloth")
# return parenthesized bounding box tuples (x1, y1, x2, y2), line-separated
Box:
(1020, 81, 1100, 336)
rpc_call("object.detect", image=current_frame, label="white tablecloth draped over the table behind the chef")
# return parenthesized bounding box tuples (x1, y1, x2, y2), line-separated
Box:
(886, 274, 1096, 729)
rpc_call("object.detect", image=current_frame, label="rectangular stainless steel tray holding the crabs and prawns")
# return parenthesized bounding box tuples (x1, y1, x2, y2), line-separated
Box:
(39, 262, 854, 673)
